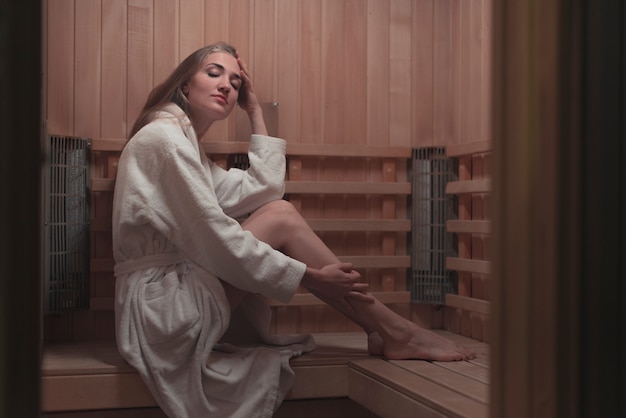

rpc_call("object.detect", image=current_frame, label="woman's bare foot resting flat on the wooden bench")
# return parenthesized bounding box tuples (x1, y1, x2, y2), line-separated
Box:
(367, 326, 476, 361)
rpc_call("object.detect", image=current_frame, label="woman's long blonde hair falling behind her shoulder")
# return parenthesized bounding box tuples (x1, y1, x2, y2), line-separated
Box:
(129, 41, 237, 138)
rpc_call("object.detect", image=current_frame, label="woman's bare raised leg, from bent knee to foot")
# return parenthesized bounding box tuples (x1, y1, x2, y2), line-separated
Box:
(242, 200, 474, 361)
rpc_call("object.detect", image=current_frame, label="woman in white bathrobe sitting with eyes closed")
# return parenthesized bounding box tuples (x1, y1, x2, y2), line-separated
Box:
(113, 43, 474, 418)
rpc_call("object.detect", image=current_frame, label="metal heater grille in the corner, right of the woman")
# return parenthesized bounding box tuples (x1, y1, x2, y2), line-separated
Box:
(409, 147, 457, 304)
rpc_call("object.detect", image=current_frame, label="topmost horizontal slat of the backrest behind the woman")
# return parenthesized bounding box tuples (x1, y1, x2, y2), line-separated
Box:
(91, 138, 412, 159)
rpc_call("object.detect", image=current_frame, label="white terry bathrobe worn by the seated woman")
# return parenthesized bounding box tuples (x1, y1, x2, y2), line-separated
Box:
(113, 105, 314, 418)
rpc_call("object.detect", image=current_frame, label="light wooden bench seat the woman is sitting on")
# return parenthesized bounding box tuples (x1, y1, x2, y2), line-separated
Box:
(42, 331, 489, 418)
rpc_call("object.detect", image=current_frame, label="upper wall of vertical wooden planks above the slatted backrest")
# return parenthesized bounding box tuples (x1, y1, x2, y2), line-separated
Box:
(46, 0, 491, 146)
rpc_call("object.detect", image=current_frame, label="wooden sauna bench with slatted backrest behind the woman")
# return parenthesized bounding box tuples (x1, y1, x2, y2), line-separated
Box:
(42, 139, 489, 418)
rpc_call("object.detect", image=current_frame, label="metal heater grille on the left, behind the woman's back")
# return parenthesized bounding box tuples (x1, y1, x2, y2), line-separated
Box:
(43, 136, 91, 314)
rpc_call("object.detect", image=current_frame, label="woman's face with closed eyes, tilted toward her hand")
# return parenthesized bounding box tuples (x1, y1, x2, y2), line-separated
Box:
(183, 52, 242, 124)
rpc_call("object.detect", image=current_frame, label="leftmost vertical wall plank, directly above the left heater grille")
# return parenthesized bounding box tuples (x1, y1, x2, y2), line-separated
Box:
(45, 0, 76, 135)
